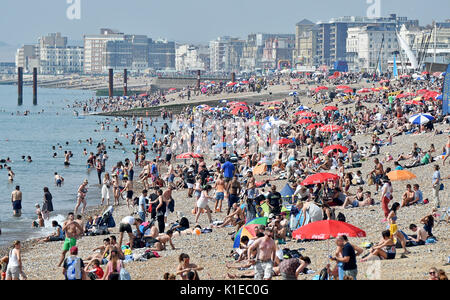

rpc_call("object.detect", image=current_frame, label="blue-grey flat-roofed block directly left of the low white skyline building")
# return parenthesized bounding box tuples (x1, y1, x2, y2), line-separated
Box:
(148, 39, 175, 70)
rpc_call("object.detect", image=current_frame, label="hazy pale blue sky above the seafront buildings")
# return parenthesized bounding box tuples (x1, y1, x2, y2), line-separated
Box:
(0, 0, 450, 61)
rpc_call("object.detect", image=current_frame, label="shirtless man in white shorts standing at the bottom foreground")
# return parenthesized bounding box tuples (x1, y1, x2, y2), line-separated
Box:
(247, 228, 277, 280)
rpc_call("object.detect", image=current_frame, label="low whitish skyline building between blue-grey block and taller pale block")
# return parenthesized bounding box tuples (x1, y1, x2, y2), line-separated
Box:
(175, 44, 209, 72)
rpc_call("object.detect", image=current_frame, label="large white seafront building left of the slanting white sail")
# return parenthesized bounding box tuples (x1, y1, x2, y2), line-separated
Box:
(346, 26, 399, 72)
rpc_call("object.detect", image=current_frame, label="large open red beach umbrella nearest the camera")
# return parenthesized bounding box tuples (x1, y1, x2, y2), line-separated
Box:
(292, 220, 366, 240)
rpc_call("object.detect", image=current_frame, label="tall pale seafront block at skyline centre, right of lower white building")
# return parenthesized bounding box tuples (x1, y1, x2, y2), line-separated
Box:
(209, 36, 245, 73)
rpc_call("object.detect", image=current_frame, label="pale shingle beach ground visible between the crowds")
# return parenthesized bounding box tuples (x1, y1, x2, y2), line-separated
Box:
(4, 77, 450, 280)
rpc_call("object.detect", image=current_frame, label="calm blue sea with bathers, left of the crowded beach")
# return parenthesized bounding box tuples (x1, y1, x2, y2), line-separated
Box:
(0, 85, 158, 246)
